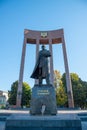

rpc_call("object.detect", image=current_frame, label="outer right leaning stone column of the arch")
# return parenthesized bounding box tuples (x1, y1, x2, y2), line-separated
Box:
(62, 36, 74, 108)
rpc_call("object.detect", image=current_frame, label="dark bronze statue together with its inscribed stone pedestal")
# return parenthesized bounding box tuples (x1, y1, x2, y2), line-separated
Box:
(30, 45, 57, 115)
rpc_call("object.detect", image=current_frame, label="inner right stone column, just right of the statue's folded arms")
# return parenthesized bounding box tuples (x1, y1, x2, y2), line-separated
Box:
(49, 39, 54, 85)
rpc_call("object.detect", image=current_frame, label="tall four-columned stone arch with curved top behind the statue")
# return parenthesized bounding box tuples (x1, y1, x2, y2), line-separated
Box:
(16, 29, 74, 108)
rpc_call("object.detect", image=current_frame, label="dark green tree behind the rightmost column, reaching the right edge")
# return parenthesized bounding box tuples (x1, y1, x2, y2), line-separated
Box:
(62, 73, 87, 108)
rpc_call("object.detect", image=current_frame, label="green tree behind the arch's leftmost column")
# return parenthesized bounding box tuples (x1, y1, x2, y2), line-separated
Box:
(8, 81, 31, 107)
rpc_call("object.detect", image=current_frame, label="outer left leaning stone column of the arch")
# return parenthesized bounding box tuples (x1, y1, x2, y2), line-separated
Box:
(16, 38, 26, 108)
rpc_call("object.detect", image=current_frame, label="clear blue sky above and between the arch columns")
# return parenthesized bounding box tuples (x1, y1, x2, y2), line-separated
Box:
(0, 0, 87, 91)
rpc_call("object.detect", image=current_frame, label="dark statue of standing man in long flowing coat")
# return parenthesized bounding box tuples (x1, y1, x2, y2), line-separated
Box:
(31, 45, 51, 84)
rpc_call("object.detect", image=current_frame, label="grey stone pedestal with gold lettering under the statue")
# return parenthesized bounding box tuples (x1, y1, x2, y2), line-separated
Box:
(30, 85, 57, 115)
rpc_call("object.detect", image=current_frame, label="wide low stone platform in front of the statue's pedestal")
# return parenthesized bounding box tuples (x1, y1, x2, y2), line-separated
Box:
(5, 114, 82, 130)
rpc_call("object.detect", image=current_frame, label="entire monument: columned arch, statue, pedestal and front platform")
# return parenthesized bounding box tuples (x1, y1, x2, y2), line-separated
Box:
(5, 29, 82, 130)
